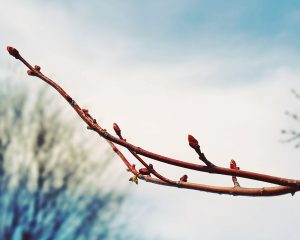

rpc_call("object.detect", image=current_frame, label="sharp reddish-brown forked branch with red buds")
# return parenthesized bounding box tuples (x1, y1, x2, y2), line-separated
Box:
(7, 47, 300, 196)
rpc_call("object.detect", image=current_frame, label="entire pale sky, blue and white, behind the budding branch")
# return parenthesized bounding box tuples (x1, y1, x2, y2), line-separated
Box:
(0, 0, 300, 240)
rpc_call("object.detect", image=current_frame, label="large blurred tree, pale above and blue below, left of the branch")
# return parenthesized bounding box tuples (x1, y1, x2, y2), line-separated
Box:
(0, 81, 132, 240)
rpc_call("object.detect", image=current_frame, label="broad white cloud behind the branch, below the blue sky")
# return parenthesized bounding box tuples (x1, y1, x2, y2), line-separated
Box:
(0, 1, 300, 239)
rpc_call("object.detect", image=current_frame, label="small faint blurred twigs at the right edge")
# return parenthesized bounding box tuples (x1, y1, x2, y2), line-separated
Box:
(281, 89, 300, 148)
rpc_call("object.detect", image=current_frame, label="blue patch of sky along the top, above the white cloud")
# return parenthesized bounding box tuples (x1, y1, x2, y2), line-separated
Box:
(49, 1, 300, 54)
